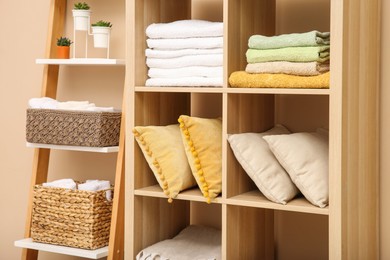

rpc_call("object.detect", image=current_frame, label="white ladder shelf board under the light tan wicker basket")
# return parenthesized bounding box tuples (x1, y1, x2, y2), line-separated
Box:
(14, 238, 108, 259)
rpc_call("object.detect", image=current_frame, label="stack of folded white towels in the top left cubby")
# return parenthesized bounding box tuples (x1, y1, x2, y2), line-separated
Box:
(145, 20, 223, 87)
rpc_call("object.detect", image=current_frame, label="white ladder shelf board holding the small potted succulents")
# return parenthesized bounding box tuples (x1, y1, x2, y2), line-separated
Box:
(36, 58, 125, 65)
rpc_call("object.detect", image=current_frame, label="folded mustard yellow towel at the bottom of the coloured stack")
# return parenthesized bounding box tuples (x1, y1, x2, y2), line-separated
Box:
(229, 71, 330, 88)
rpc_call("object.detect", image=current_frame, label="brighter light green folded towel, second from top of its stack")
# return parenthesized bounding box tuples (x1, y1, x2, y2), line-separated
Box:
(246, 45, 329, 63)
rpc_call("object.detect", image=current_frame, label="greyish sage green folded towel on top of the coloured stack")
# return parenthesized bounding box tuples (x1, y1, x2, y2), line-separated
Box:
(248, 31, 330, 49)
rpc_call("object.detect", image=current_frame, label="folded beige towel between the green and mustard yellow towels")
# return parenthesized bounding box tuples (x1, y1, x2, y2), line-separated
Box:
(245, 61, 329, 76)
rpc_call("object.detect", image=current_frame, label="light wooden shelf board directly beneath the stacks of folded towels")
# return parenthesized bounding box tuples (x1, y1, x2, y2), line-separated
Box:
(135, 86, 330, 95)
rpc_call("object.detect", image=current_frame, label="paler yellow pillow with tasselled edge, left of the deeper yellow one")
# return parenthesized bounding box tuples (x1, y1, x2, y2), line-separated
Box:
(133, 124, 196, 202)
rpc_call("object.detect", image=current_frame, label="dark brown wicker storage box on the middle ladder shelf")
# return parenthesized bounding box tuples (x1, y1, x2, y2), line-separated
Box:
(26, 109, 121, 147)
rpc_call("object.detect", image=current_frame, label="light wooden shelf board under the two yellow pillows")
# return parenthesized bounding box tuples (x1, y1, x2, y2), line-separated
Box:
(134, 185, 222, 203)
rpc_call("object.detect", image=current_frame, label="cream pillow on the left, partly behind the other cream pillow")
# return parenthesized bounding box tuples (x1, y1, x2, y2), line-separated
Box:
(228, 125, 299, 204)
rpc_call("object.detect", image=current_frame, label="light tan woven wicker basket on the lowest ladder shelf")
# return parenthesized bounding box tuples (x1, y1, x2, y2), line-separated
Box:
(31, 185, 112, 249)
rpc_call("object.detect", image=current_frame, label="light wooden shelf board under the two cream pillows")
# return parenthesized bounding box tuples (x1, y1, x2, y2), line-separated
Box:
(226, 190, 329, 215)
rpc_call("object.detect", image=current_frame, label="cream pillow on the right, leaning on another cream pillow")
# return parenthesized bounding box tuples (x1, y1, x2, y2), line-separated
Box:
(263, 131, 329, 208)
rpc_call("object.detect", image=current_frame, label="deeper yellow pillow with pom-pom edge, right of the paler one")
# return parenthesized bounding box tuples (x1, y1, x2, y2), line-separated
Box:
(178, 115, 222, 203)
